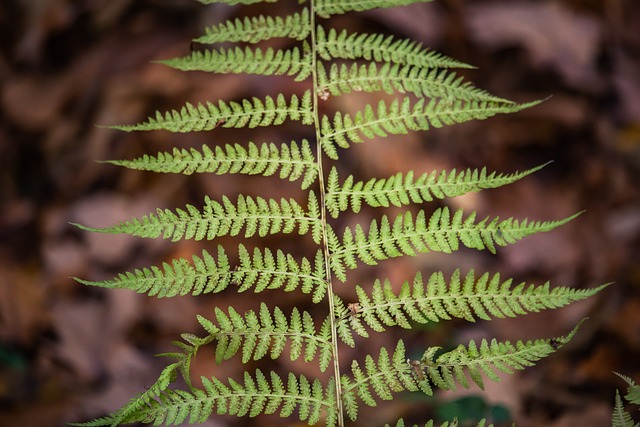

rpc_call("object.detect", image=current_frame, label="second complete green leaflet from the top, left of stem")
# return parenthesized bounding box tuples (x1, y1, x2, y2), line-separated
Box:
(159, 43, 311, 81)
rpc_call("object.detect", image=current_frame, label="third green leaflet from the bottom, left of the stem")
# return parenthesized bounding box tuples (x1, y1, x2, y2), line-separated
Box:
(74, 244, 327, 303)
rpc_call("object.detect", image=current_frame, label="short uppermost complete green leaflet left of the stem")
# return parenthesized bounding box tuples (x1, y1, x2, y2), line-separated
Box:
(194, 7, 311, 44)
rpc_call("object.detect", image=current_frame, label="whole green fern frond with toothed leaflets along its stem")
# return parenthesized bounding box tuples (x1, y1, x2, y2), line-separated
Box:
(78, 0, 602, 426)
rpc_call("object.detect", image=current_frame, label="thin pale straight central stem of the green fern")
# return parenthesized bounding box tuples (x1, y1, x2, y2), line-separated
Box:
(309, 0, 345, 427)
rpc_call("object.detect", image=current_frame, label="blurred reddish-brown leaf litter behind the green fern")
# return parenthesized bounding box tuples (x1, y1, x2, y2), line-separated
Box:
(0, 0, 640, 427)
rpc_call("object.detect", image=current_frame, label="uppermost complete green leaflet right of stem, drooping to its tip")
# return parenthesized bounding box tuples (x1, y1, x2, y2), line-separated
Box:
(316, 26, 473, 68)
